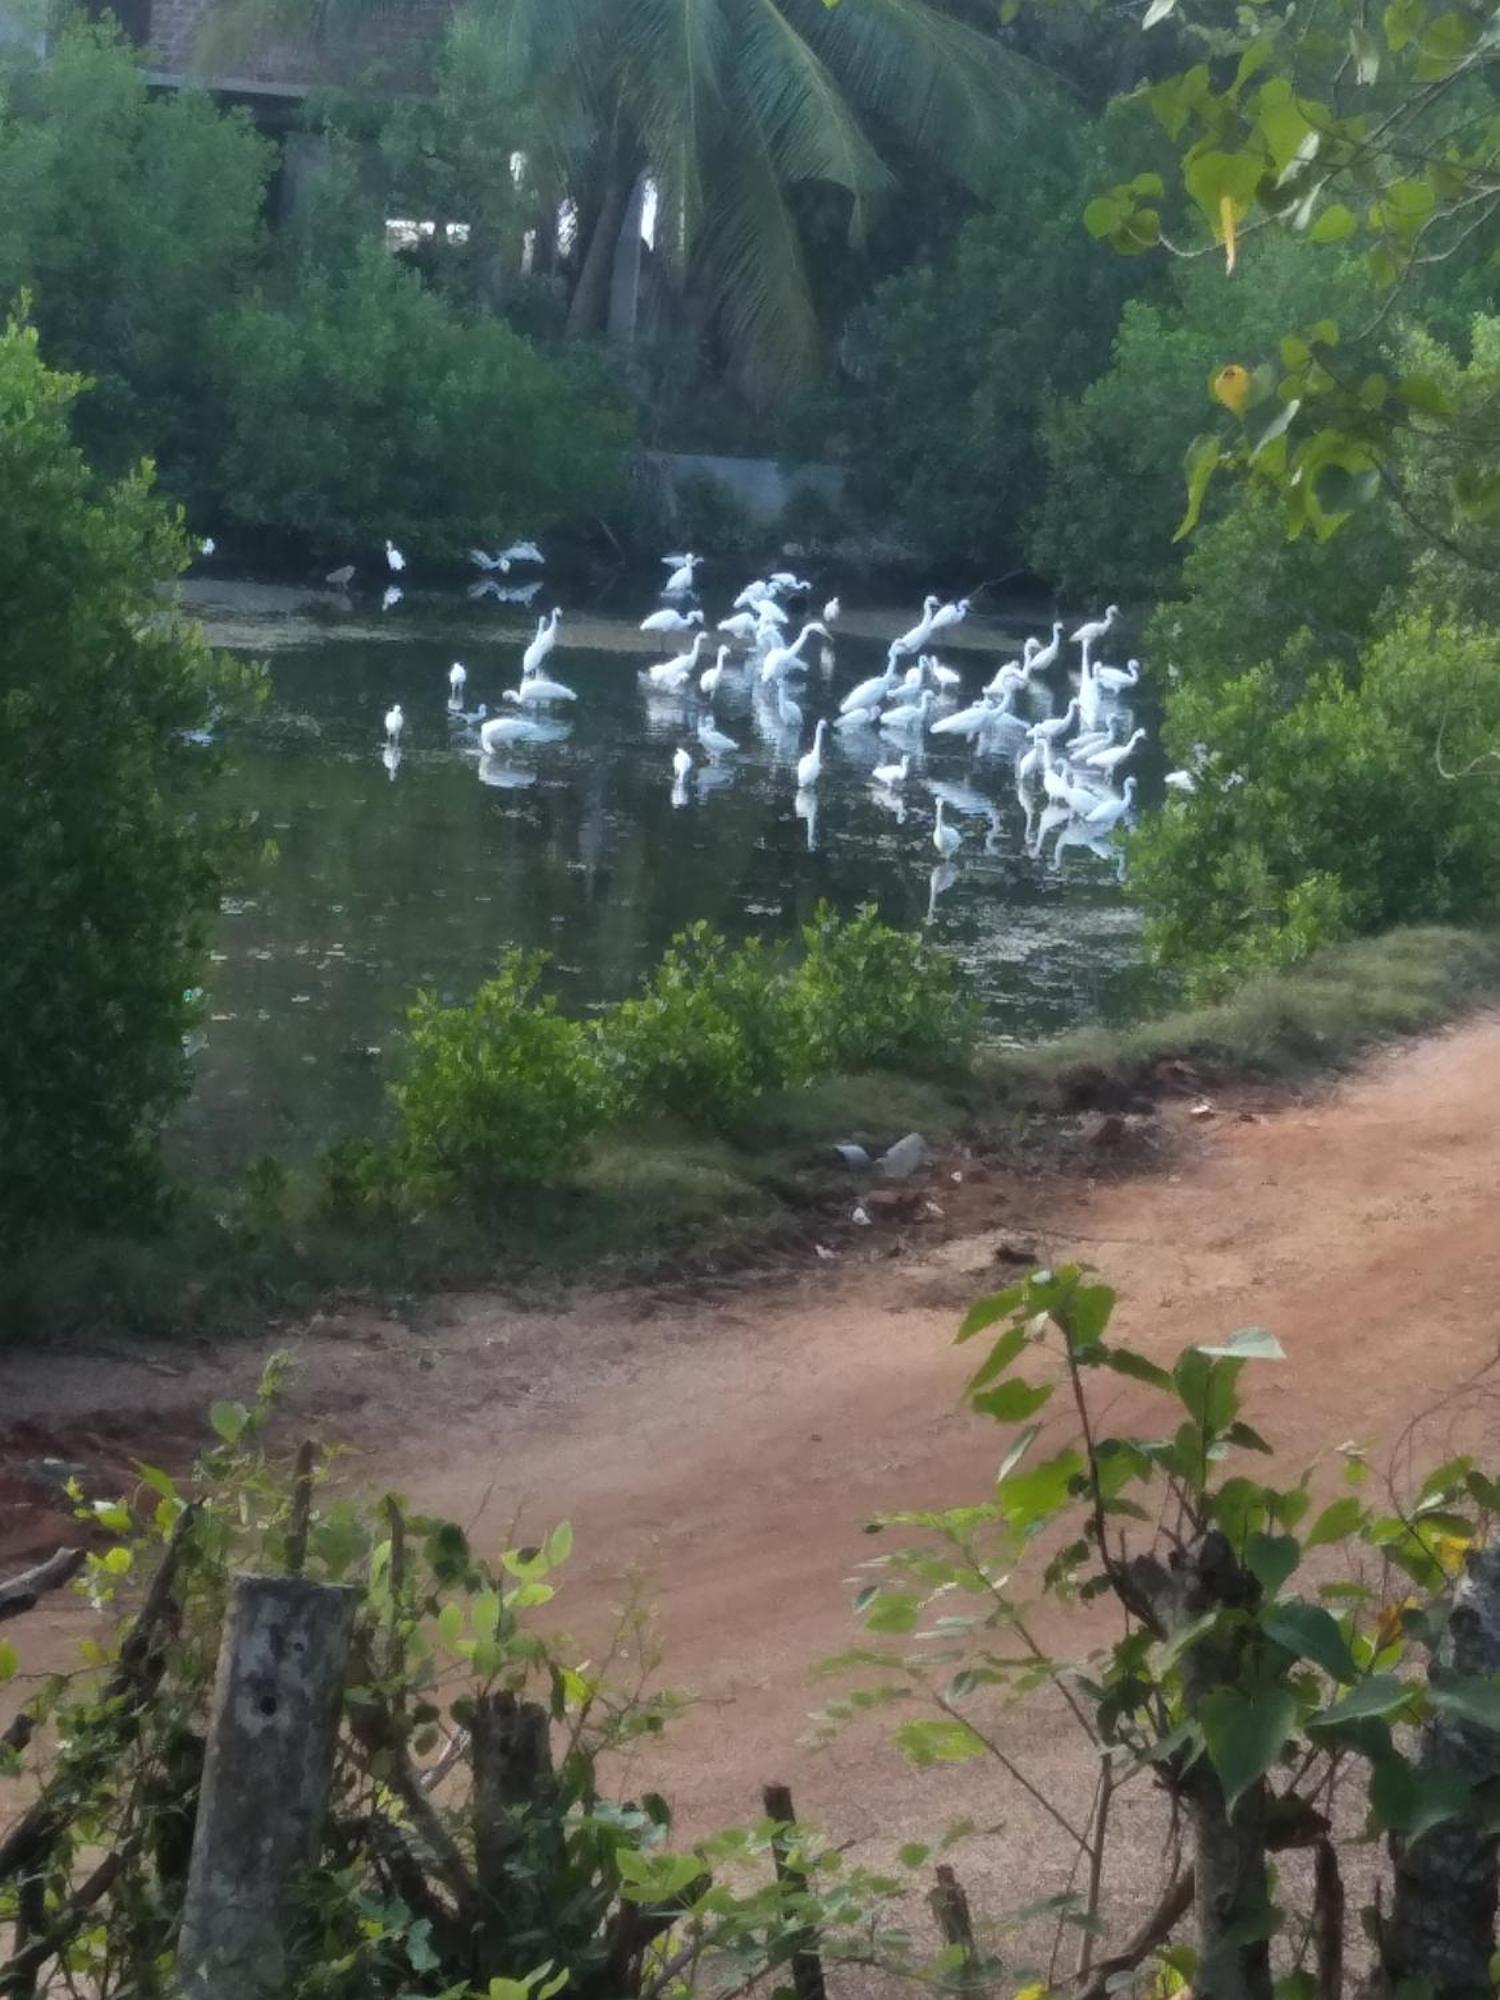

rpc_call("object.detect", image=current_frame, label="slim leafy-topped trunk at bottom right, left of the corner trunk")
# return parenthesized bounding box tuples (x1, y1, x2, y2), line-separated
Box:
(1130, 1532, 1272, 2000)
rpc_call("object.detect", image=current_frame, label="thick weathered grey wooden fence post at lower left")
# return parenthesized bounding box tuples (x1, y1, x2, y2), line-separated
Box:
(178, 1576, 356, 2000)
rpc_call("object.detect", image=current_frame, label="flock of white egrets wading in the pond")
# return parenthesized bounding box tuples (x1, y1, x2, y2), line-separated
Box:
(374, 542, 1194, 900)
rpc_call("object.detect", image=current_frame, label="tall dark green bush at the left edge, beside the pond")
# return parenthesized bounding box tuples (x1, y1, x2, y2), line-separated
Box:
(0, 324, 256, 1236)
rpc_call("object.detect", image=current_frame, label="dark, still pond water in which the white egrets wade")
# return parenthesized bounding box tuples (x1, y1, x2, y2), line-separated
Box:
(182, 580, 1140, 1172)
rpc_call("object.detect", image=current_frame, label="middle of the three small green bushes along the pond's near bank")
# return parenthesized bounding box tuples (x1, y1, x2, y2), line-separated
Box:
(598, 924, 794, 1128)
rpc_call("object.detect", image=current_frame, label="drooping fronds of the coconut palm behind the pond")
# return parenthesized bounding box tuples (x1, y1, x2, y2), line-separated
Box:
(197, 0, 1022, 396)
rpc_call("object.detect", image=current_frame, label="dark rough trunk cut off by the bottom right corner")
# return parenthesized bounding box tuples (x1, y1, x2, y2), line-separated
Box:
(1380, 1548, 1500, 2000)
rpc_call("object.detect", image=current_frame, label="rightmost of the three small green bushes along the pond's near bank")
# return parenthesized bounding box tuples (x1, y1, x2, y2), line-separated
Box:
(788, 904, 980, 1076)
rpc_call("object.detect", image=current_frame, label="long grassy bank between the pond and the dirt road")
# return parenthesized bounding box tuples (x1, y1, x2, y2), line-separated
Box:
(0, 928, 1500, 1342)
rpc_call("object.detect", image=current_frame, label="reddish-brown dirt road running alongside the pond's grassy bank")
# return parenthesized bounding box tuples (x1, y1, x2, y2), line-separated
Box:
(0, 1018, 1500, 1936)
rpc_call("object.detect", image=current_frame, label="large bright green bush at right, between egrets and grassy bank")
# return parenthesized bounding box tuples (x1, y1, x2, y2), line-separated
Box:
(1130, 614, 1500, 994)
